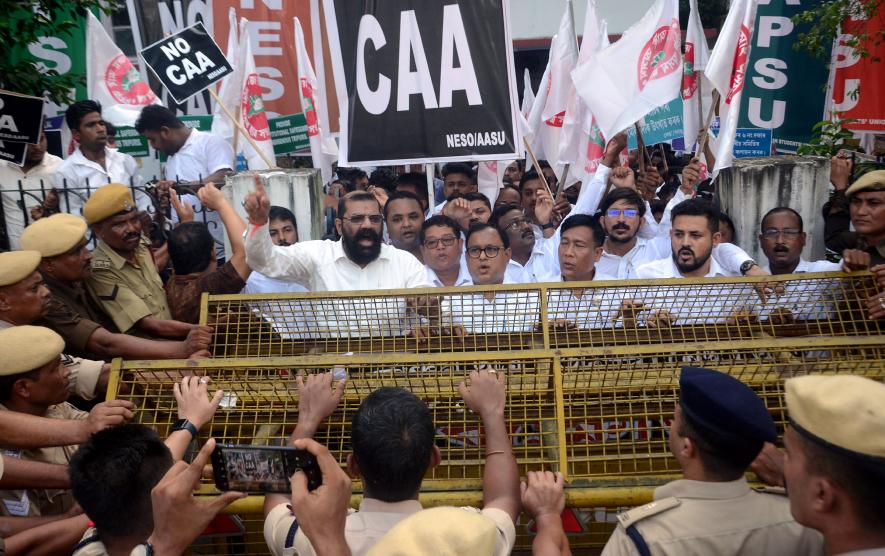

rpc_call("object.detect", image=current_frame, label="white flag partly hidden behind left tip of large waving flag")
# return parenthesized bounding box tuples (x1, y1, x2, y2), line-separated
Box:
(558, 0, 609, 180)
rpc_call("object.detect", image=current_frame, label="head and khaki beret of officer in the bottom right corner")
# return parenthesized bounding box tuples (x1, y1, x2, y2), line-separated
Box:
(784, 375, 885, 556)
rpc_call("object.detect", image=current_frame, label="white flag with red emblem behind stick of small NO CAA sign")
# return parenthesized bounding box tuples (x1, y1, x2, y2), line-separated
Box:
(212, 8, 275, 170)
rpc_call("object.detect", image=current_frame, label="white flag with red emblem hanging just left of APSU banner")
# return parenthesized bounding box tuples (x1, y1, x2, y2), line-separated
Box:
(705, 0, 756, 173)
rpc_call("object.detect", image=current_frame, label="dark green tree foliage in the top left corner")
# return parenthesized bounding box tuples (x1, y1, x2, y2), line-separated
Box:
(0, 0, 117, 104)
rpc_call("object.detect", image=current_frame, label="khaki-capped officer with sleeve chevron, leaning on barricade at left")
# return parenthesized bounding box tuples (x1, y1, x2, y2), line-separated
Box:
(83, 183, 194, 338)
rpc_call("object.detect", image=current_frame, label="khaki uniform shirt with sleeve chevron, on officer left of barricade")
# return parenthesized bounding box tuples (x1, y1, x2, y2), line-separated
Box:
(86, 239, 172, 332)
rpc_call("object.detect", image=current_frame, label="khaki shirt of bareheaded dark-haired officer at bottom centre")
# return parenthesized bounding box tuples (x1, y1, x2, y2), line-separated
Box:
(264, 498, 516, 556)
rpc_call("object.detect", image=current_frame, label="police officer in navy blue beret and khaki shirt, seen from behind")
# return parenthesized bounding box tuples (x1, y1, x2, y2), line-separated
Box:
(602, 367, 823, 556)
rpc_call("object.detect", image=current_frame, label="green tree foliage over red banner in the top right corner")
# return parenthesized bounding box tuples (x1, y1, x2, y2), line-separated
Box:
(793, 0, 885, 62)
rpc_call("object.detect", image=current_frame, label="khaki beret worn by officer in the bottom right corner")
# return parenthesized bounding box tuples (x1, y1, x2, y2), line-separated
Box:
(786, 375, 885, 464)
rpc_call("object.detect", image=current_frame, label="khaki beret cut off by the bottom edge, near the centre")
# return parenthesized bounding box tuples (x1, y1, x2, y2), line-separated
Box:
(368, 507, 498, 556)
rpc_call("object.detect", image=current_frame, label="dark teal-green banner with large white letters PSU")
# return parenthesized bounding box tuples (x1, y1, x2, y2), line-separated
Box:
(738, 0, 828, 152)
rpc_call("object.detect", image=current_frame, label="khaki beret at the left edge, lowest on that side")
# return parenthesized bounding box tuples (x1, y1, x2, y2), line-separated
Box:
(0, 326, 65, 376)
